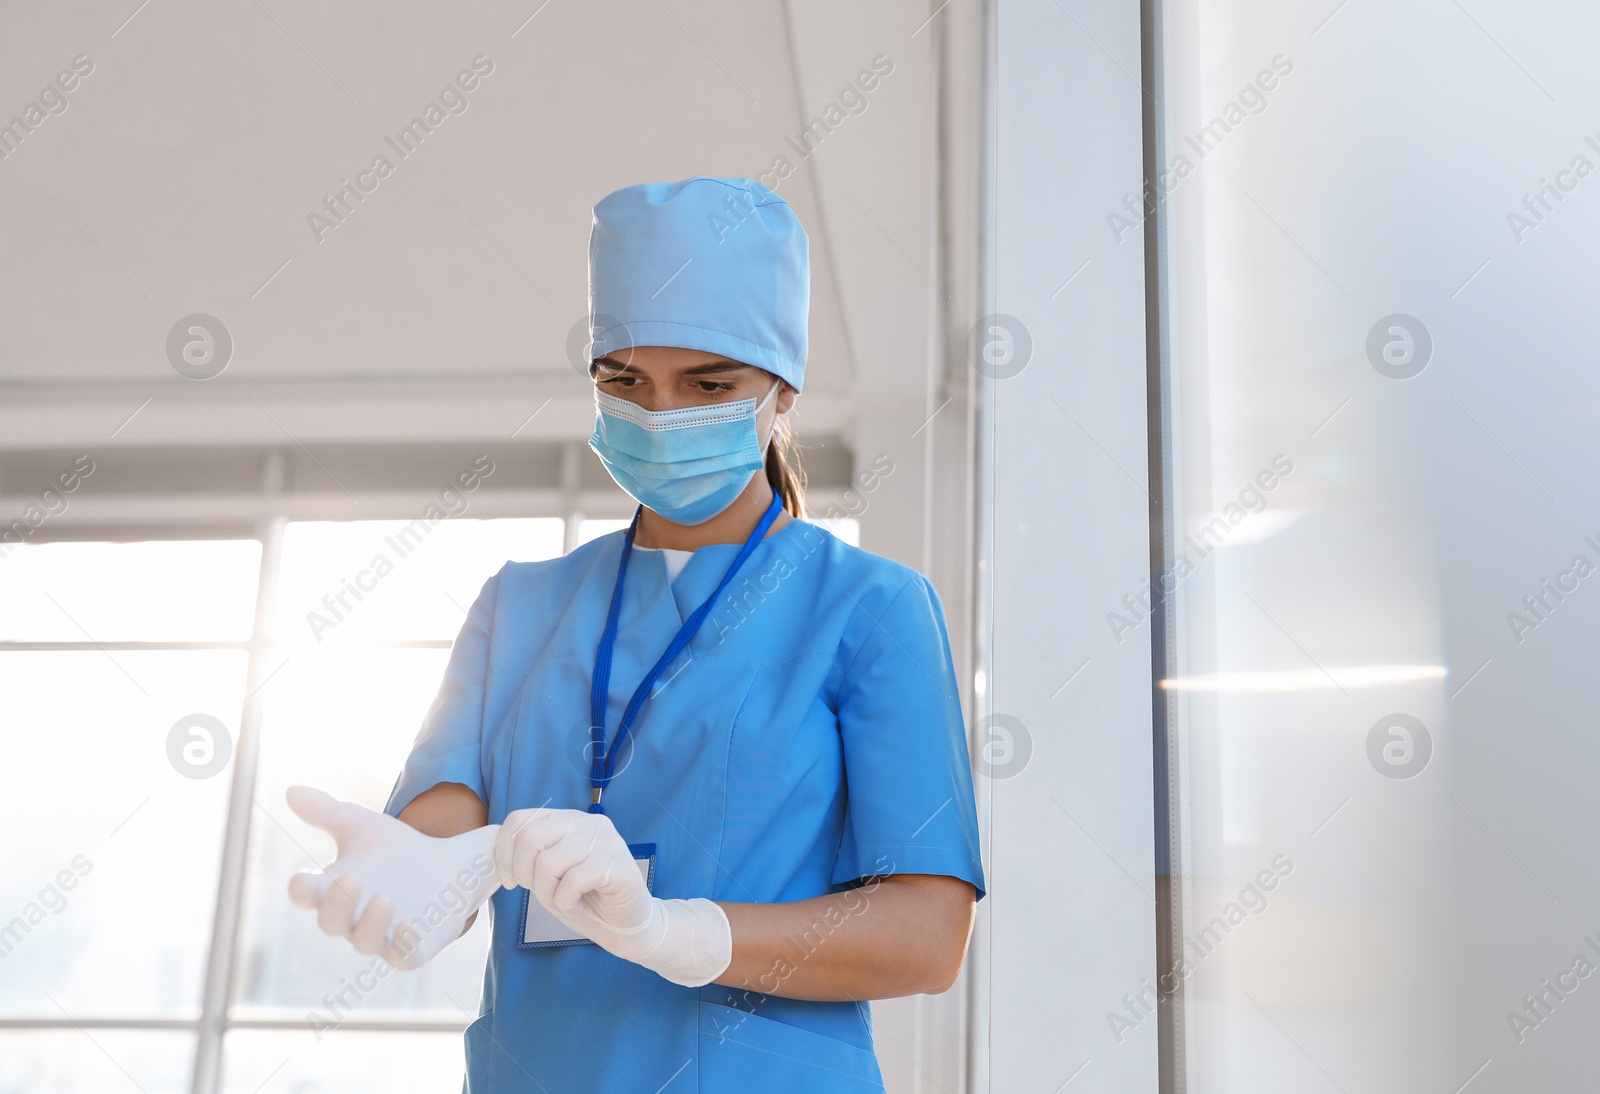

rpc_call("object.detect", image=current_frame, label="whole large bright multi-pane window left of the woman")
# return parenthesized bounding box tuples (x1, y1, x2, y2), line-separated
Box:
(0, 518, 566, 1094)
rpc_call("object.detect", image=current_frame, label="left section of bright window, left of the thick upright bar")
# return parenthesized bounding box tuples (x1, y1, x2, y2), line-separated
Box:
(0, 539, 261, 1094)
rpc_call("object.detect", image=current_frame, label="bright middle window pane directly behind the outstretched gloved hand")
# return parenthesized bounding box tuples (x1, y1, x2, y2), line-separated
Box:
(235, 648, 488, 1017)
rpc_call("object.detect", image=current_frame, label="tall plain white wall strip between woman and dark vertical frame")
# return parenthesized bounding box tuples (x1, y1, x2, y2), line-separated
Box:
(976, 0, 1155, 1094)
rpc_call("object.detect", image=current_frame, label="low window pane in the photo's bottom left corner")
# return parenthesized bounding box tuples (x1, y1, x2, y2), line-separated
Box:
(0, 1030, 195, 1094)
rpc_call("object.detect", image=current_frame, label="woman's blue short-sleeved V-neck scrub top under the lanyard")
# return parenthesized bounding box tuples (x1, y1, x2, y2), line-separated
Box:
(387, 520, 984, 1094)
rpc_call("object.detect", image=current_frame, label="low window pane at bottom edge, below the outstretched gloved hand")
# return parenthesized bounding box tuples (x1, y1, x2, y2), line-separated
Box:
(222, 1019, 466, 1094)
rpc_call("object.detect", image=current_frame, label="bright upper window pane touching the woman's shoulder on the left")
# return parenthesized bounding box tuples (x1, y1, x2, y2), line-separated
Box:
(274, 518, 563, 648)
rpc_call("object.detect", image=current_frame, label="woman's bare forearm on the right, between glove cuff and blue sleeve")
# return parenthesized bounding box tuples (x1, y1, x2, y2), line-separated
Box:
(717, 873, 978, 1000)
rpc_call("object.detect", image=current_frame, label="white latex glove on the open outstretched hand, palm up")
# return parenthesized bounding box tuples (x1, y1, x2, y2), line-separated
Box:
(285, 787, 499, 969)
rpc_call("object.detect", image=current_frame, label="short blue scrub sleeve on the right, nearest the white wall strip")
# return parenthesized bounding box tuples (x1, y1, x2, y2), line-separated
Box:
(832, 574, 984, 897)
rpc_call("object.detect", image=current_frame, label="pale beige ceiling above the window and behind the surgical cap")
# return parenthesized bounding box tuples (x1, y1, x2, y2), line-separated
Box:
(0, 0, 949, 449)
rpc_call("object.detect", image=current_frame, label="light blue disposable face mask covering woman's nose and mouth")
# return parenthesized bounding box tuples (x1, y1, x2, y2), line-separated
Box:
(589, 381, 778, 525)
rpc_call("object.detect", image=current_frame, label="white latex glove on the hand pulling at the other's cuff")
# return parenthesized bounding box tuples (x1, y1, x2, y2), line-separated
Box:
(494, 808, 733, 987)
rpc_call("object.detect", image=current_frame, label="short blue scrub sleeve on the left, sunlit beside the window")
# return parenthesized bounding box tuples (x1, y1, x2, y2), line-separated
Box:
(384, 566, 506, 817)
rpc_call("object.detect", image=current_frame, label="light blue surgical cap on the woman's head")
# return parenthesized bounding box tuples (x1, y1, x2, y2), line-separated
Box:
(589, 176, 811, 390)
